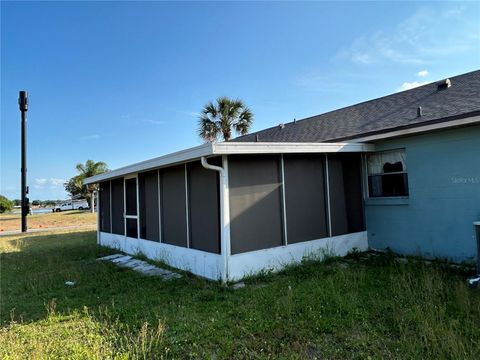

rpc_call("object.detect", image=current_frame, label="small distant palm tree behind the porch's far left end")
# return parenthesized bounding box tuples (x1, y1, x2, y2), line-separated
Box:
(64, 160, 108, 212)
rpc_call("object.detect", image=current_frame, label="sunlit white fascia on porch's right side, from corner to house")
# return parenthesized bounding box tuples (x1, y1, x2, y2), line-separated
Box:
(213, 142, 375, 155)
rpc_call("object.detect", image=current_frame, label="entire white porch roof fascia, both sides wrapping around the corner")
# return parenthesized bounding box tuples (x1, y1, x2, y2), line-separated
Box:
(83, 142, 375, 184)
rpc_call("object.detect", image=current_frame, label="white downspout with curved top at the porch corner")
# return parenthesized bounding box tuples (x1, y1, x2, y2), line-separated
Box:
(200, 156, 230, 284)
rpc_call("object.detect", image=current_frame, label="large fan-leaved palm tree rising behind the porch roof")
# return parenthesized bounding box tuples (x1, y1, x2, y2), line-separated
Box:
(198, 97, 253, 142)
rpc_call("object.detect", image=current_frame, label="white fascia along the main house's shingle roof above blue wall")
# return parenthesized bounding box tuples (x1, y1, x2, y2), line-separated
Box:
(350, 116, 480, 142)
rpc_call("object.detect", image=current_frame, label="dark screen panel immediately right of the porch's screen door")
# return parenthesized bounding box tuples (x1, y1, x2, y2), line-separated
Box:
(138, 170, 160, 241)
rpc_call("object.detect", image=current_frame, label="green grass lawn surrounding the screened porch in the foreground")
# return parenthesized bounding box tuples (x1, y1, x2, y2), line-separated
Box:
(0, 231, 480, 359)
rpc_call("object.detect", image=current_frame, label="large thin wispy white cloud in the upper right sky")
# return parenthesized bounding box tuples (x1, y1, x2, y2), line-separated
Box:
(335, 4, 479, 65)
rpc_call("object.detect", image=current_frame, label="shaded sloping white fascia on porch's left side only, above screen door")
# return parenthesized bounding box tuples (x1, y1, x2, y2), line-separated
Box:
(83, 143, 213, 184)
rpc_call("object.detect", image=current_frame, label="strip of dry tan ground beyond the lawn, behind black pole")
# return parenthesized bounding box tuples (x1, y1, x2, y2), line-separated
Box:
(0, 210, 97, 234)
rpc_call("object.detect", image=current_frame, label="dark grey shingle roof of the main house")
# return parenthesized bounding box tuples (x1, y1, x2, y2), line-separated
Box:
(231, 70, 480, 142)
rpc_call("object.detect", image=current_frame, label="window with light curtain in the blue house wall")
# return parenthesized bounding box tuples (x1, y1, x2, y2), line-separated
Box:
(368, 149, 408, 197)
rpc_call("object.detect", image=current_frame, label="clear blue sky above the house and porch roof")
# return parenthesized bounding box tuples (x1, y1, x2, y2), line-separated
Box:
(0, 1, 480, 200)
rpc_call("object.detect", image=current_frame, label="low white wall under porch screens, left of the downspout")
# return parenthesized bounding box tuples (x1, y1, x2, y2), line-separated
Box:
(100, 232, 223, 280)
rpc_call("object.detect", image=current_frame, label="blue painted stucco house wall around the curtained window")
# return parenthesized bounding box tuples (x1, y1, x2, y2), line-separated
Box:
(365, 126, 480, 262)
